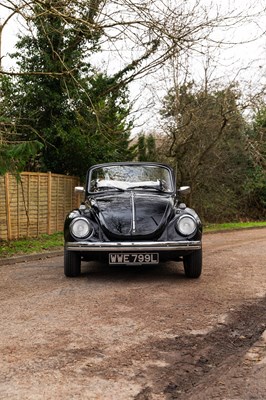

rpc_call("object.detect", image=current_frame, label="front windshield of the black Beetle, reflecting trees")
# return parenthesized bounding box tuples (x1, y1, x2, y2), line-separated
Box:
(88, 164, 174, 193)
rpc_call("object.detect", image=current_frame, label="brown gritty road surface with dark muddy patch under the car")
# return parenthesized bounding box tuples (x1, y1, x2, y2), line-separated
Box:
(0, 229, 266, 400)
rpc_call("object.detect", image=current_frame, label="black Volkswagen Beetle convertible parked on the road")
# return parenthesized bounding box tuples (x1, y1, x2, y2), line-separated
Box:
(64, 162, 202, 278)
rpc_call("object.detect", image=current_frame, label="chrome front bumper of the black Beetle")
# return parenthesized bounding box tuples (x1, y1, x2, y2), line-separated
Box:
(65, 240, 201, 252)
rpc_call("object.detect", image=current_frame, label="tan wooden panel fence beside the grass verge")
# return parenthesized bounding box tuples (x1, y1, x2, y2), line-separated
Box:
(0, 172, 80, 240)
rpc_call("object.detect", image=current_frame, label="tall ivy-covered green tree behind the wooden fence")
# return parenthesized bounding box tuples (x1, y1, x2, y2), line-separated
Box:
(0, 0, 133, 176)
